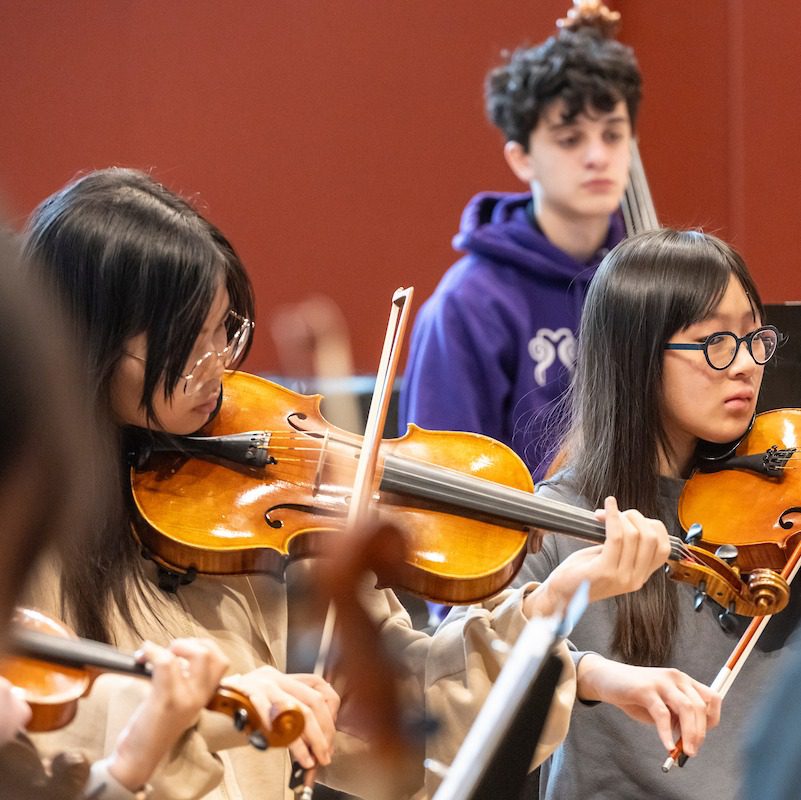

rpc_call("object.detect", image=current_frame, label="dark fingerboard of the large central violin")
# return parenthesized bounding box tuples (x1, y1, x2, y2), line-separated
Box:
(381, 456, 606, 543)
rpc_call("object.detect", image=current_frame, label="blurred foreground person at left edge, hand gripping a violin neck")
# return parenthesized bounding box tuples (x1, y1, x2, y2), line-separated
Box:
(0, 240, 233, 800)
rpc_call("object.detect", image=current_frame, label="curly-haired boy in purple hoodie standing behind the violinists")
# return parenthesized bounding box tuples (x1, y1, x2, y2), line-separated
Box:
(399, 29, 640, 480)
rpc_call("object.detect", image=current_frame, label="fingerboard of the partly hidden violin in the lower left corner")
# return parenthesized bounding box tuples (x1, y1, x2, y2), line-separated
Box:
(11, 626, 150, 677)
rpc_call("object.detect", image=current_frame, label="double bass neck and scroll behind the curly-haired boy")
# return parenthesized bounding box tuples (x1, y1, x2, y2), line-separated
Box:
(556, 0, 659, 236)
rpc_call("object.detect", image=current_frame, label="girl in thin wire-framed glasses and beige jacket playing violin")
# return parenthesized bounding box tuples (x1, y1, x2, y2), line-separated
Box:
(27, 169, 669, 798)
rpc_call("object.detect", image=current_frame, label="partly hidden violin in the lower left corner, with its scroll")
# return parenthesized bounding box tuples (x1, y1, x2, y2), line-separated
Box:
(0, 609, 304, 749)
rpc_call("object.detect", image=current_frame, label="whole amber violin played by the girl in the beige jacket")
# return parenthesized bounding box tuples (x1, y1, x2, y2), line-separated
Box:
(131, 373, 788, 616)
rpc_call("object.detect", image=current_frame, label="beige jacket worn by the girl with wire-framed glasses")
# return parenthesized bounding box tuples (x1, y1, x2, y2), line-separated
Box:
(30, 556, 575, 800)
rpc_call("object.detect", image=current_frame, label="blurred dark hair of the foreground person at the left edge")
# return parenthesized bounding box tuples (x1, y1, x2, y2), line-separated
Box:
(0, 233, 107, 639)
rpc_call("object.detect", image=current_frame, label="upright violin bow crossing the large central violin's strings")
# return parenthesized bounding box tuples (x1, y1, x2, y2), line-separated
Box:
(290, 287, 414, 800)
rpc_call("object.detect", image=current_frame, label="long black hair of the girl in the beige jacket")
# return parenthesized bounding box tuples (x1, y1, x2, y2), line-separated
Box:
(25, 168, 254, 641)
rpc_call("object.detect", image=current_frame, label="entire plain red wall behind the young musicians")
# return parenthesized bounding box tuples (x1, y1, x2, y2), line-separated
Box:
(0, 0, 801, 371)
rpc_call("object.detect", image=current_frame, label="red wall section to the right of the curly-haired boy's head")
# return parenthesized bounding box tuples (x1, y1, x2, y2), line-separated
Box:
(617, 0, 801, 302)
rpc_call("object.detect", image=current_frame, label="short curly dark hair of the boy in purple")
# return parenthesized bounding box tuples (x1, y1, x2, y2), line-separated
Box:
(485, 29, 641, 149)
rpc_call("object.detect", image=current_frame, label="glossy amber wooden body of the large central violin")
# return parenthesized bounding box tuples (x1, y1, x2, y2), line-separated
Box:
(132, 373, 533, 603)
